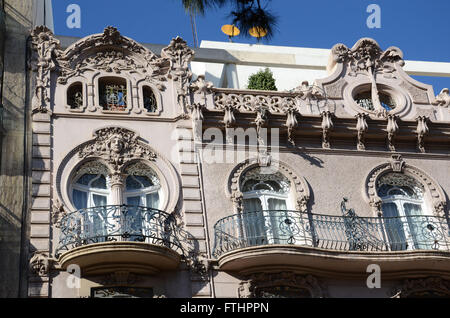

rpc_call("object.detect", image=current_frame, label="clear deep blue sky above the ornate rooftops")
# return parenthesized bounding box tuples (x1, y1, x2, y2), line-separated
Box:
(53, 0, 450, 94)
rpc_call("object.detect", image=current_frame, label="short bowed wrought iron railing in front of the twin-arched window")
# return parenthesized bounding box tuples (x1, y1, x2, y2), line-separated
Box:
(56, 205, 191, 256)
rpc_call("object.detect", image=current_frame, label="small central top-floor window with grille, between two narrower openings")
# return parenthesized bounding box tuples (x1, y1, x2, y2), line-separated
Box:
(98, 77, 128, 111)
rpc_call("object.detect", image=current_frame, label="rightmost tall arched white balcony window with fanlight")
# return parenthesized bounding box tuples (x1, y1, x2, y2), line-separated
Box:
(377, 172, 432, 250)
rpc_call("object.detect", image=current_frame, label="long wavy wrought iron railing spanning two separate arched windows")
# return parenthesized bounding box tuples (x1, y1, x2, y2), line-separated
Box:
(213, 210, 450, 257)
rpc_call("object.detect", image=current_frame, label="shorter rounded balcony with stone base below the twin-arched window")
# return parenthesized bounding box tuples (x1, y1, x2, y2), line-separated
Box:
(56, 205, 190, 275)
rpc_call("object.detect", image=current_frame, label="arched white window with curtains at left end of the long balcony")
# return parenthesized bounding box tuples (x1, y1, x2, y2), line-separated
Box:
(240, 168, 292, 245)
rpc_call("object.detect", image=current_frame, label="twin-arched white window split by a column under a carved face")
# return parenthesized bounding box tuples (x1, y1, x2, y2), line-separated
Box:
(71, 161, 164, 242)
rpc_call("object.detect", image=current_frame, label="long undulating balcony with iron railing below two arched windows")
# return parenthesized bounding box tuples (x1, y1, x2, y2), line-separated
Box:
(213, 210, 450, 277)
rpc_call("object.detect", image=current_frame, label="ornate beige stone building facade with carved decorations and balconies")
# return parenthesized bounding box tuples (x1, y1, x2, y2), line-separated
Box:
(21, 27, 450, 297)
